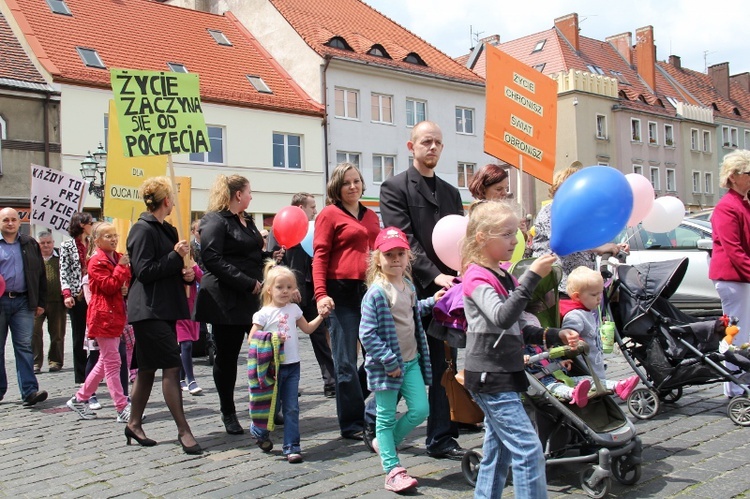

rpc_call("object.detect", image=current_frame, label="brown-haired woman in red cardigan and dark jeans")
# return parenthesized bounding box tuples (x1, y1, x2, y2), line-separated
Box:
(313, 163, 380, 440)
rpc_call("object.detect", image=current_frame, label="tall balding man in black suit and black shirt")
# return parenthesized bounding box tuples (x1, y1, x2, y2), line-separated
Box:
(380, 121, 465, 459)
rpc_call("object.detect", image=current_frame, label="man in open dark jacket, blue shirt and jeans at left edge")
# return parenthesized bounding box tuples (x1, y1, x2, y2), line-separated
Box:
(0, 208, 47, 406)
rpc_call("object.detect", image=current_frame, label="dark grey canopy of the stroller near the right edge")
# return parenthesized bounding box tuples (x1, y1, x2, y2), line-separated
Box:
(617, 258, 688, 334)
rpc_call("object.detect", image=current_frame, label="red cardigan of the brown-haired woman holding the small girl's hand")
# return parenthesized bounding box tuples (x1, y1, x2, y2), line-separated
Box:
(313, 204, 380, 300)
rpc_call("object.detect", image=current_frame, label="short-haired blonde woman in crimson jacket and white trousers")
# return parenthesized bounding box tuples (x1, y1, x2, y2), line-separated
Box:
(708, 150, 750, 398)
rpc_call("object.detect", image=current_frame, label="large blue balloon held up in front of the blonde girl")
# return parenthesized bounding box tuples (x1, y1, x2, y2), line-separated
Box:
(550, 166, 633, 256)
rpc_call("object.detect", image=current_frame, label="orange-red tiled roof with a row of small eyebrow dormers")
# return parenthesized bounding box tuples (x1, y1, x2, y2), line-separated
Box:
(269, 0, 484, 84)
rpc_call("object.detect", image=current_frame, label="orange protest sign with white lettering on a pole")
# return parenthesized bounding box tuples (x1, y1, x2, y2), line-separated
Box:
(484, 45, 557, 184)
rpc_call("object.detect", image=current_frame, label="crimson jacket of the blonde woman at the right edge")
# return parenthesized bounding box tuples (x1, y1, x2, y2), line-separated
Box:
(708, 189, 750, 283)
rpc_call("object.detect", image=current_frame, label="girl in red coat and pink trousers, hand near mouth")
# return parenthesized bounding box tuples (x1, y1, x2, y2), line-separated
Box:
(67, 222, 130, 423)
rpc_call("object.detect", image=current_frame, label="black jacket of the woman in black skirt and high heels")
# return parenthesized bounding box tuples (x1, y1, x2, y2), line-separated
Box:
(127, 213, 190, 323)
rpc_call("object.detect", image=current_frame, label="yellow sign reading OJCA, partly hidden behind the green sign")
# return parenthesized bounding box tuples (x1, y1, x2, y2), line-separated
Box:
(104, 101, 167, 222)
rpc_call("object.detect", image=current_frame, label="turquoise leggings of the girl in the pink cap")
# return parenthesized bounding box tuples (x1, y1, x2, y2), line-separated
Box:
(375, 356, 430, 473)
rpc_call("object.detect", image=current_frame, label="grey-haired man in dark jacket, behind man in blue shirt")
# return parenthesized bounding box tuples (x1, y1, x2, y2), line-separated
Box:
(31, 231, 66, 373)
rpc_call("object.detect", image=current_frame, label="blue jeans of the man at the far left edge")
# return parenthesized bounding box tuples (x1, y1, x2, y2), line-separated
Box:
(0, 296, 39, 400)
